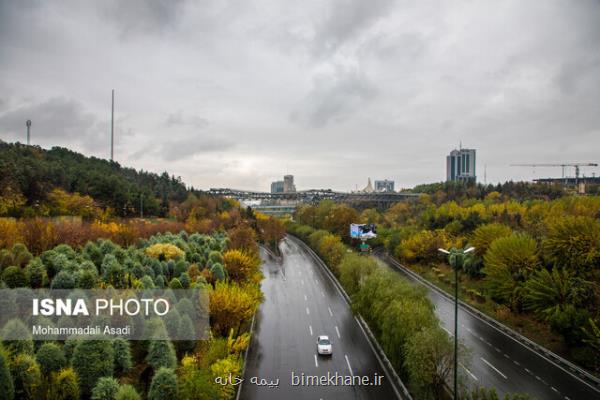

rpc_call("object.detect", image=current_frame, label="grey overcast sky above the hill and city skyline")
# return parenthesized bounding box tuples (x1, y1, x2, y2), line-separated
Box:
(0, 0, 600, 190)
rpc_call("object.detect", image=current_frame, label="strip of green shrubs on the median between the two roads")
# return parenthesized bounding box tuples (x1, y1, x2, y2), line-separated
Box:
(286, 221, 529, 400)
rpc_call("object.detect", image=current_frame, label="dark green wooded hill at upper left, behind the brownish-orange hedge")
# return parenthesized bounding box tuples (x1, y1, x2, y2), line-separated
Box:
(0, 141, 188, 217)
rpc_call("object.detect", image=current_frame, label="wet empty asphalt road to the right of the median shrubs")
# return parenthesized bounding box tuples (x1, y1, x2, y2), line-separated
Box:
(380, 255, 600, 400)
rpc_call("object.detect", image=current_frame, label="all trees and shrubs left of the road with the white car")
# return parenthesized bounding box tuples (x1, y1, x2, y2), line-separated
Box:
(0, 143, 285, 400)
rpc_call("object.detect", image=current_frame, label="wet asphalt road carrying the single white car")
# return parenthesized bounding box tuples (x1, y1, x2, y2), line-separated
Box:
(241, 238, 397, 400)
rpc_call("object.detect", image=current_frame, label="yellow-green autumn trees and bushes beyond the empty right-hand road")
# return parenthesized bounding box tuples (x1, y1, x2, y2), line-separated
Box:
(294, 191, 600, 375)
